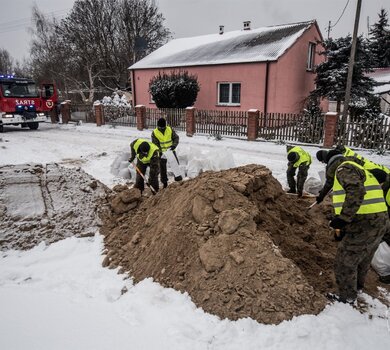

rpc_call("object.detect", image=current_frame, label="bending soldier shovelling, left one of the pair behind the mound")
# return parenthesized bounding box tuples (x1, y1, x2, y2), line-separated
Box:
(129, 139, 160, 192)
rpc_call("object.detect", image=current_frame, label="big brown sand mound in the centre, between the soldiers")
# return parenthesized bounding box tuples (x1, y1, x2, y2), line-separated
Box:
(101, 165, 386, 323)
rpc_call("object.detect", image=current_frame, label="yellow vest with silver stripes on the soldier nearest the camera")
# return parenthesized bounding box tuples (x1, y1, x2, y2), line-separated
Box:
(332, 161, 387, 215)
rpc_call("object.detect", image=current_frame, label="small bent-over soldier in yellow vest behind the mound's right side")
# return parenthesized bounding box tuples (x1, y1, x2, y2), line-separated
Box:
(287, 146, 311, 197)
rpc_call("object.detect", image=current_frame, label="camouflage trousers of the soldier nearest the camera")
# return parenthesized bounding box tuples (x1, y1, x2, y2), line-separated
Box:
(334, 213, 389, 301)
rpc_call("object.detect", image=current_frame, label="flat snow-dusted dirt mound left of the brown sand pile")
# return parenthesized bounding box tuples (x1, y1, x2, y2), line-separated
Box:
(0, 164, 110, 250)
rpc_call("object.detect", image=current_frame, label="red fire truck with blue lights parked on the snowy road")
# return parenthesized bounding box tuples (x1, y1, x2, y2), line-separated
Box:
(0, 74, 58, 132)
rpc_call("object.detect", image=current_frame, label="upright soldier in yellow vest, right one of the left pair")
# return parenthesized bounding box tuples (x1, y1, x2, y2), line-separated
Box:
(152, 118, 179, 188)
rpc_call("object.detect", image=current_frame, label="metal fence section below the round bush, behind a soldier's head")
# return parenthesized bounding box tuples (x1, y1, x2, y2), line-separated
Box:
(146, 108, 186, 131)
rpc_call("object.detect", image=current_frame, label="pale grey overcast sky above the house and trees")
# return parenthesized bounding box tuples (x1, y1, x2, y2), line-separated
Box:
(0, 0, 390, 60)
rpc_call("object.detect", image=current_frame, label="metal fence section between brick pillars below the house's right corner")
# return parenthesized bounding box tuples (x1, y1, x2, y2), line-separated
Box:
(258, 113, 324, 143)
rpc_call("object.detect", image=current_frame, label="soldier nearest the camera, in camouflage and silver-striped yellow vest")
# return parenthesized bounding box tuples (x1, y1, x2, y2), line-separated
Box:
(326, 150, 389, 303)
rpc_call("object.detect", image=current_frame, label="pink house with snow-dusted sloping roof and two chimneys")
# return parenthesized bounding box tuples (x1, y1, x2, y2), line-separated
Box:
(129, 21, 324, 113)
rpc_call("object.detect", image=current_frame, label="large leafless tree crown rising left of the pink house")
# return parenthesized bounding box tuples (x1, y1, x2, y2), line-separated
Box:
(31, 0, 170, 101)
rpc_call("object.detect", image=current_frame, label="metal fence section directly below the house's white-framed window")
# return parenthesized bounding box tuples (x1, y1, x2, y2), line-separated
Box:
(195, 110, 248, 138)
